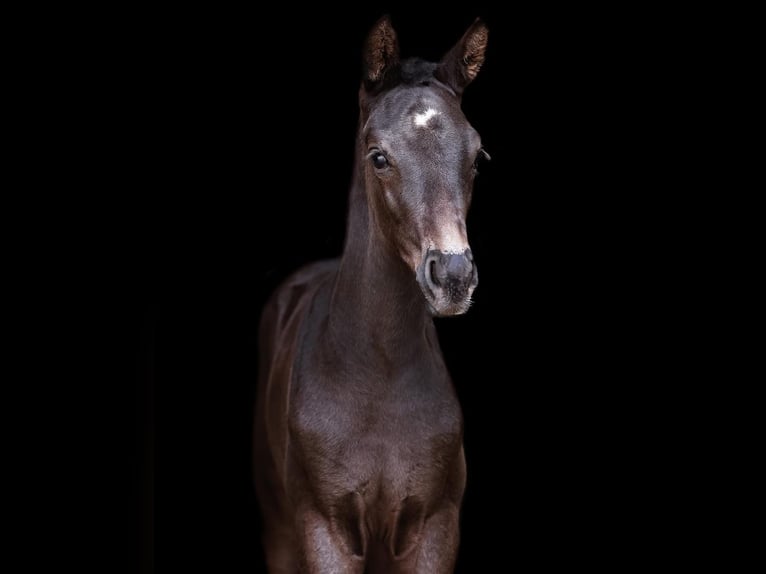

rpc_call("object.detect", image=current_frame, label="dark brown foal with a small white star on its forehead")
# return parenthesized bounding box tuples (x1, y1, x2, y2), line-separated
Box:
(253, 16, 489, 574)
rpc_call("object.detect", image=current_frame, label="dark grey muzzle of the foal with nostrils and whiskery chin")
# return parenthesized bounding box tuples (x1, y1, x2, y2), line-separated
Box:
(417, 249, 479, 317)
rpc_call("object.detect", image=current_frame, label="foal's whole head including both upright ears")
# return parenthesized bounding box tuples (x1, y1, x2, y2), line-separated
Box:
(359, 17, 488, 315)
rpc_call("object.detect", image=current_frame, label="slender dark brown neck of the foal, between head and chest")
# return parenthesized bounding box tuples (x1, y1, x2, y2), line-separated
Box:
(329, 146, 433, 363)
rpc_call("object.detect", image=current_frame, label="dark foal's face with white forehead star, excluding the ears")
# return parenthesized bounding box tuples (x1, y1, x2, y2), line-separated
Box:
(363, 88, 486, 315)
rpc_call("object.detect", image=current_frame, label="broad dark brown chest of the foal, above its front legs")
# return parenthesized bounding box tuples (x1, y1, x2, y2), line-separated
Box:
(290, 374, 462, 498)
